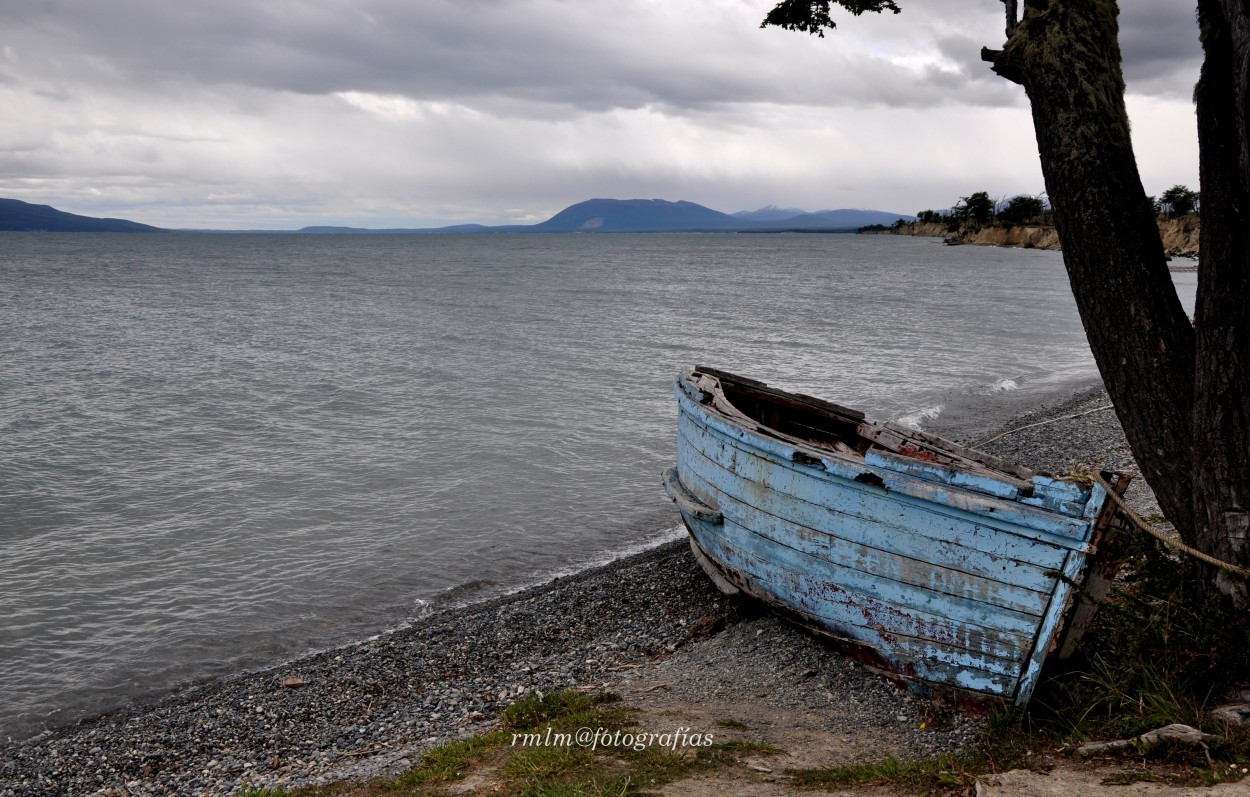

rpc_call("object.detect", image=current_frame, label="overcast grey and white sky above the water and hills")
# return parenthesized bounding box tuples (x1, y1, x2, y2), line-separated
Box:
(0, 0, 1201, 229)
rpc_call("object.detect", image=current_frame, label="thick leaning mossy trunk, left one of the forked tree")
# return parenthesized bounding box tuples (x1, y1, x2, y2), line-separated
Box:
(983, 0, 1198, 543)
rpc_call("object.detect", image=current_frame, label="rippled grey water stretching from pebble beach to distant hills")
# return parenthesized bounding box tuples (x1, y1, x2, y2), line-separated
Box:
(0, 234, 1184, 740)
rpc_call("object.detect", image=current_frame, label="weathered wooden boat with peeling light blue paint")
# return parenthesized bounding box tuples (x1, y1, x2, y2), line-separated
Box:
(664, 367, 1129, 706)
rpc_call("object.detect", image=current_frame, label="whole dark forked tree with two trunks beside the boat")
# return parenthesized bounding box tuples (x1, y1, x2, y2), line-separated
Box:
(983, 0, 1250, 603)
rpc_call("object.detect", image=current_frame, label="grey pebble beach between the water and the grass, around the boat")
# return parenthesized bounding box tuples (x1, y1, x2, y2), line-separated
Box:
(0, 386, 1153, 797)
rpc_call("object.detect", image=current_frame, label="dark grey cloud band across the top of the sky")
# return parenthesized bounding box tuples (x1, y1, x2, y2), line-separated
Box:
(7, 0, 1196, 110)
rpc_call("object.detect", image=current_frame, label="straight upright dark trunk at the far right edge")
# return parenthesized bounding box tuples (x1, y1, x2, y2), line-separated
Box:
(1190, 0, 1250, 603)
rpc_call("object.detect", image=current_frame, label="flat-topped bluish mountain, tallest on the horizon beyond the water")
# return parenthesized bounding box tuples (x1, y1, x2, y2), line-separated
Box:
(527, 199, 743, 232)
